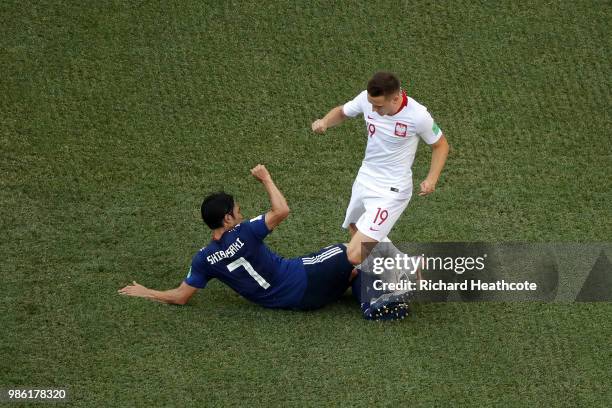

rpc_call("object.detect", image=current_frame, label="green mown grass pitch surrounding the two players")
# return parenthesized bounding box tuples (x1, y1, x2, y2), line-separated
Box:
(0, 0, 612, 407)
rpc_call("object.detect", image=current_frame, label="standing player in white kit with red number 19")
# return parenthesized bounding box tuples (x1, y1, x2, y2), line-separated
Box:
(312, 72, 449, 265)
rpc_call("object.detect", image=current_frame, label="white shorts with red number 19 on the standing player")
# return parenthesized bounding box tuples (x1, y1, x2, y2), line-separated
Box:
(342, 181, 410, 242)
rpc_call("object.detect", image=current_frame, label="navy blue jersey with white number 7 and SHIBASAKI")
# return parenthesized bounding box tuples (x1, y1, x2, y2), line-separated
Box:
(185, 215, 307, 308)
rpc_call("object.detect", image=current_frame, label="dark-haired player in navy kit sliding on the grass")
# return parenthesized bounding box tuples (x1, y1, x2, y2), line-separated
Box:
(119, 165, 408, 320)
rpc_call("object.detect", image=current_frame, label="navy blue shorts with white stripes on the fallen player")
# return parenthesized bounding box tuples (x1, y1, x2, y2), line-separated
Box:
(297, 244, 354, 310)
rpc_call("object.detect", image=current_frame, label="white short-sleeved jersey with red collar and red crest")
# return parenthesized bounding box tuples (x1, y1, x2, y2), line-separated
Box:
(342, 91, 442, 198)
